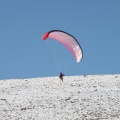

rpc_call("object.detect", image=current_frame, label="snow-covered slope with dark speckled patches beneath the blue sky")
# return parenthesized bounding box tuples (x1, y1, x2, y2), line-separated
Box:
(0, 75, 120, 120)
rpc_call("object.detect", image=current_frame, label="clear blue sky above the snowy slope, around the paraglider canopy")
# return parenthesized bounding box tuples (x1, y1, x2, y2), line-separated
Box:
(0, 0, 120, 79)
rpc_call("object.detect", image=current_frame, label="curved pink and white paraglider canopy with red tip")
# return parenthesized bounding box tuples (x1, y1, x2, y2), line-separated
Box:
(42, 30, 83, 62)
